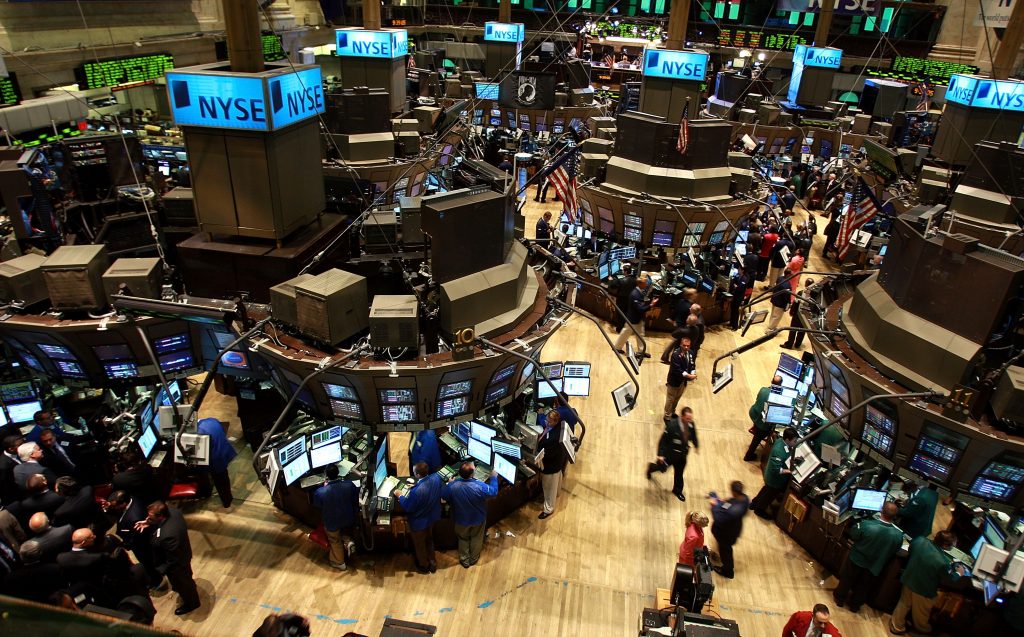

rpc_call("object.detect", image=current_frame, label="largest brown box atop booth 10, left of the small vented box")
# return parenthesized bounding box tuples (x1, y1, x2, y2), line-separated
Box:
(295, 268, 370, 345)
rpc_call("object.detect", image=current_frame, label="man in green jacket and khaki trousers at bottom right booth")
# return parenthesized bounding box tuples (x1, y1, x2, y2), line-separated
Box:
(889, 530, 967, 635)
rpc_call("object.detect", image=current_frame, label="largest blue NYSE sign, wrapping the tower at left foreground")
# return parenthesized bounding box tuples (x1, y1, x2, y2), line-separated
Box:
(167, 67, 324, 131)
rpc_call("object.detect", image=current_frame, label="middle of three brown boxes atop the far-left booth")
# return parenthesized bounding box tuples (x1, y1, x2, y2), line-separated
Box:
(42, 245, 110, 309)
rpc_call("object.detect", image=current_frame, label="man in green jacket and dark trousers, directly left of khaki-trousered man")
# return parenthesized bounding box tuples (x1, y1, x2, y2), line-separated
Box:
(833, 502, 903, 612)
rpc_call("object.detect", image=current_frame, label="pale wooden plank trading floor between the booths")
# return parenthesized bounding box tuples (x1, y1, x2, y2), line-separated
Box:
(156, 193, 905, 637)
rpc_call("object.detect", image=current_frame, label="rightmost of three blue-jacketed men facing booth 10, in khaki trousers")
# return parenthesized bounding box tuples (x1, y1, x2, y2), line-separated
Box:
(441, 461, 498, 568)
